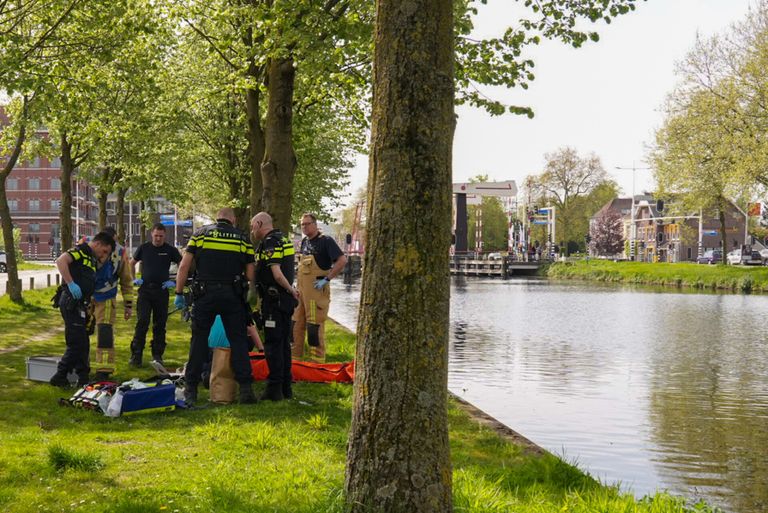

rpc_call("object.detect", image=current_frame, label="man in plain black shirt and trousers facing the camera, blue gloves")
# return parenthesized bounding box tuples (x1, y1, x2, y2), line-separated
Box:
(129, 223, 181, 367)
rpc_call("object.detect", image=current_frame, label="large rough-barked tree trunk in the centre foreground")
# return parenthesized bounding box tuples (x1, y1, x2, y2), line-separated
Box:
(345, 0, 455, 513)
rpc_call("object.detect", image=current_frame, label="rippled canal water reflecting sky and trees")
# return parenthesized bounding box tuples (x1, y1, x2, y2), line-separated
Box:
(331, 278, 768, 513)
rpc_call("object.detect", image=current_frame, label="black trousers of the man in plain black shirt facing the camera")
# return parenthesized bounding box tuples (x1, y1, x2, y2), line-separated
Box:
(131, 283, 168, 358)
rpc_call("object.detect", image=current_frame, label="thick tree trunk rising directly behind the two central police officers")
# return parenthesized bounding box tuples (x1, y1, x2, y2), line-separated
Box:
(261, 58, 296, 233)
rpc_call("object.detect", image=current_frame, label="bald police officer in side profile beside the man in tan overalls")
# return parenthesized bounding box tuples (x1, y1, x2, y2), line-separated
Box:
(251, 212, 299, 401)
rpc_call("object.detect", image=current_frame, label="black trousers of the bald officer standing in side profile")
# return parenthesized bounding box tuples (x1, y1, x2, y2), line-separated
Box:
(261, 295, 295, 386)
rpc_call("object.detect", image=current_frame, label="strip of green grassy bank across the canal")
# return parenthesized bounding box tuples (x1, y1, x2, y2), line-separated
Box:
(541, 260, 768, 292)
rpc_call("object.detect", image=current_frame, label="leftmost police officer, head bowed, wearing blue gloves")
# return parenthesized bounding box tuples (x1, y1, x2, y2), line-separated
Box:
(50, 232, 115, 387)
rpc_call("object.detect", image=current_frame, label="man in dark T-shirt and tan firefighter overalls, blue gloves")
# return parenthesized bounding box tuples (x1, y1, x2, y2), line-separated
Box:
(293, 213, 347, 362)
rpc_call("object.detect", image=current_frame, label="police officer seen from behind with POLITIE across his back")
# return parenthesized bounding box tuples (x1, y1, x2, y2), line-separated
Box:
(174, 208, 257, 406)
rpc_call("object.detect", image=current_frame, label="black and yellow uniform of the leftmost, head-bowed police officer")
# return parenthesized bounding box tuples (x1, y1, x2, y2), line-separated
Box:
(51, 243, 96, 385)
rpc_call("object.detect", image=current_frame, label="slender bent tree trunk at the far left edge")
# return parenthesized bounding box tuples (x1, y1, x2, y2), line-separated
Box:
(0, 96, 29, 303)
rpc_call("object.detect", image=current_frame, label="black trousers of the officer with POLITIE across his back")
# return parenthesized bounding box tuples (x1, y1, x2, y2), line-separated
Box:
(184, 282, 253, 388)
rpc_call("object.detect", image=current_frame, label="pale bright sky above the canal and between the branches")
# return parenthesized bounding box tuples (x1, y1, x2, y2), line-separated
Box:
(347, 0, 754, 208)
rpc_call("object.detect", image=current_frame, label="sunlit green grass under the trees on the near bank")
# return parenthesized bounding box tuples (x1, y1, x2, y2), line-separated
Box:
(0, 290, 711, 513)
